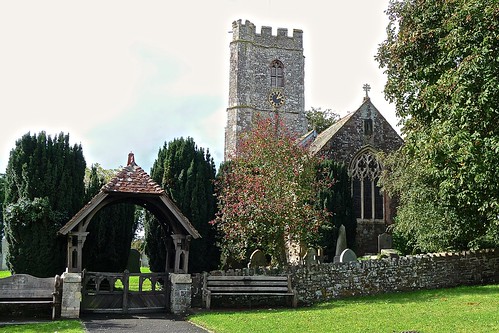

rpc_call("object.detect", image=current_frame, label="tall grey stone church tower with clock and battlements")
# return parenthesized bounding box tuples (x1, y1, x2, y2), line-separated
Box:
(225, 20, 307, 160)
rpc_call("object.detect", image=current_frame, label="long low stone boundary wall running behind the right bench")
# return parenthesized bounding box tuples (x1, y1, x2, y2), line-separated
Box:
(192, 249, 499, 306)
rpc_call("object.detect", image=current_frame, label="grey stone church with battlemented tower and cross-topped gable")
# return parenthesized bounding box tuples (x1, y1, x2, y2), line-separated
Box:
(225, 20, 403, 254)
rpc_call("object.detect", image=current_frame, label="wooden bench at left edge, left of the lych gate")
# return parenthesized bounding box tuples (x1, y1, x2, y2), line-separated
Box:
(0, 274, 61, 319)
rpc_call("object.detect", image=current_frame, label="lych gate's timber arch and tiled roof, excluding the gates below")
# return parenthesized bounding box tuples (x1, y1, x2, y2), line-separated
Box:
(59, 153, 201, 273)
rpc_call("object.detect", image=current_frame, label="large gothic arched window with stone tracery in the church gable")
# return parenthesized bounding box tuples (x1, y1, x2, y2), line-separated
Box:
(350, 150, 384, 220)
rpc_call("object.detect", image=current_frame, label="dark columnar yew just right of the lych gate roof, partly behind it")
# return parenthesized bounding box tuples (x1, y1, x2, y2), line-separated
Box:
(144, 138, 220, 272)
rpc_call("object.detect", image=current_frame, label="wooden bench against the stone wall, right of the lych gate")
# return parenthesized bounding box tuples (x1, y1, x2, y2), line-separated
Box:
(203, 275, 298, 309)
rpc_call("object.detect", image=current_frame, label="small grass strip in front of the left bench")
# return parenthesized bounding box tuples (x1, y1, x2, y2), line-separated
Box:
(0, 320, 85, 333)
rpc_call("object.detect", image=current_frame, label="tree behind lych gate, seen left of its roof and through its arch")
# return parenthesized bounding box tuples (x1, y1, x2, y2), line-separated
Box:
(83, 164, 137, 272)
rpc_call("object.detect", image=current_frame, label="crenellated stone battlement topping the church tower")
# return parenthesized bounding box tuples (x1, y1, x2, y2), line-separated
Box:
(232, 20, 303, 50)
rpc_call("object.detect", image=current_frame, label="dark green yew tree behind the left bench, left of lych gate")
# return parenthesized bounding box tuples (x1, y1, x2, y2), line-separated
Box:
(5, 132, 85, 277)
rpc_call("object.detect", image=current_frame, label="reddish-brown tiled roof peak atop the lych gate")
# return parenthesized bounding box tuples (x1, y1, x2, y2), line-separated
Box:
(102, 153, 164, 194)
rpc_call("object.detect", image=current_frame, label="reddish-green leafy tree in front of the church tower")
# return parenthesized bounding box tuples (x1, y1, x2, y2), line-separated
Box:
(214, 117, 328, 265)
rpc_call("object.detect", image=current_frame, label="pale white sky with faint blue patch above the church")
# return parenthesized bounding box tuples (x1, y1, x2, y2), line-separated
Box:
(0, 0, 397, 173)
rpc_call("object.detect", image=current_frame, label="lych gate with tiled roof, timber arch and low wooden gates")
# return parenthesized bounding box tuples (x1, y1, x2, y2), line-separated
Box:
(59, 153, 200, 312)
